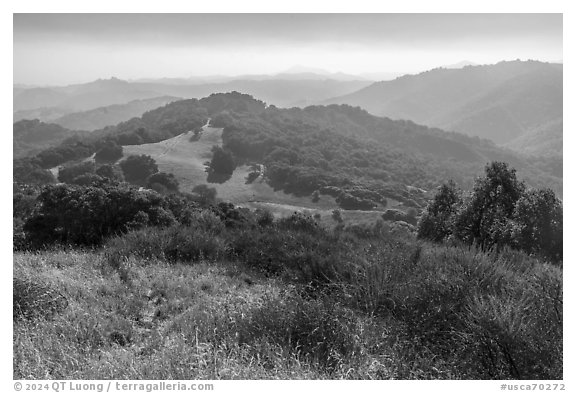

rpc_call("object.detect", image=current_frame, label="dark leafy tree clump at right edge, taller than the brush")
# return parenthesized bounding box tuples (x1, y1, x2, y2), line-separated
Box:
(418, 162, 563, 262)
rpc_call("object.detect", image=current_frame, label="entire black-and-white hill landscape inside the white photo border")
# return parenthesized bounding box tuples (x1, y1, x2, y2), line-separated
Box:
(13, 14, 563, 380)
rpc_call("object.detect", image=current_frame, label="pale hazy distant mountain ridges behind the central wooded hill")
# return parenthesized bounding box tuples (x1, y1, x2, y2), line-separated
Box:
(13, 73, 371, 114)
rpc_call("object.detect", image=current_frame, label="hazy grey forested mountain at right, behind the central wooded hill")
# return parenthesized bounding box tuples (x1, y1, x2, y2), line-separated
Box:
(325, 61, 563, 148)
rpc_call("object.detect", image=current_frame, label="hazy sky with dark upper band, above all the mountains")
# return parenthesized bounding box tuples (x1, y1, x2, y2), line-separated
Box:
(14, 14, 562, 85)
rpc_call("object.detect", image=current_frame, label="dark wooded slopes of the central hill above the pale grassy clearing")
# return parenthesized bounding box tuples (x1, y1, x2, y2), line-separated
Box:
(14, 92, 562, 200)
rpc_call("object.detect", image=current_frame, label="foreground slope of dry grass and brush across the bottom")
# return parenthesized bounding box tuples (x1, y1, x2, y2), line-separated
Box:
(14, 211, 563, 379)
